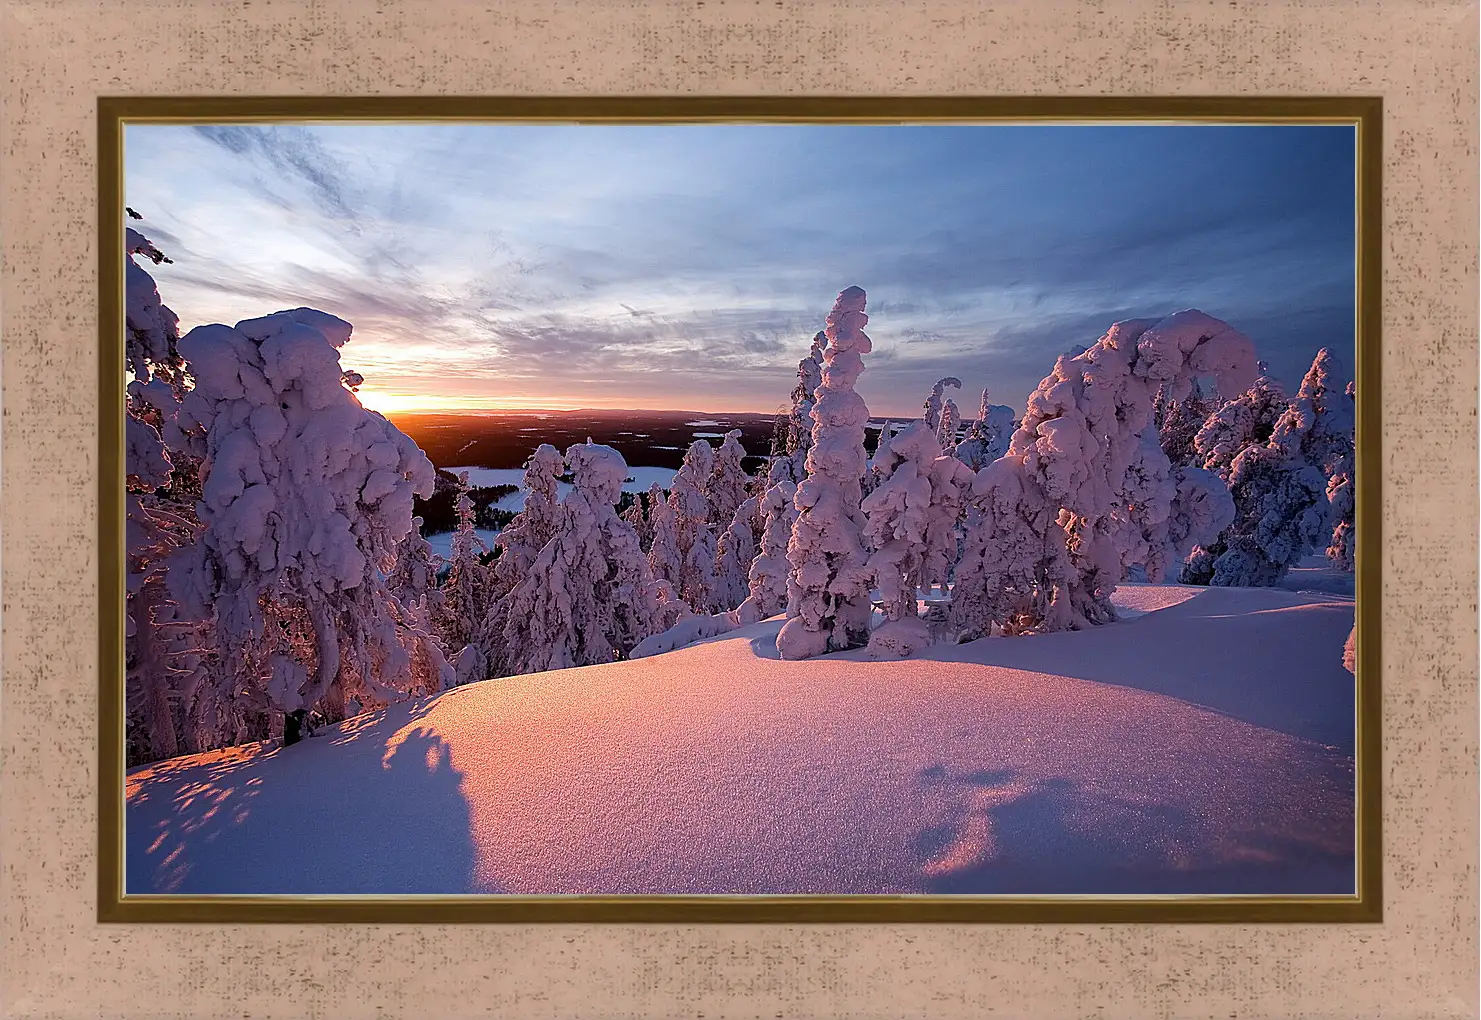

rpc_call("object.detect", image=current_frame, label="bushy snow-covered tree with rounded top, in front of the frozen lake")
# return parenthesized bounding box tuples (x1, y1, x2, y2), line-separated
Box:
(490, 443, 661, 674)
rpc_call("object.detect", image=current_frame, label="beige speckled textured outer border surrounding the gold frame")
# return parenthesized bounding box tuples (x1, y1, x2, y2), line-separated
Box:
(0, 0, 1477, 1019)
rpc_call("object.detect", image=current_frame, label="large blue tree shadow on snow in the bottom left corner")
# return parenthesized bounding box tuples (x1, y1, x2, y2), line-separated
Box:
(124, 706, 485, 894)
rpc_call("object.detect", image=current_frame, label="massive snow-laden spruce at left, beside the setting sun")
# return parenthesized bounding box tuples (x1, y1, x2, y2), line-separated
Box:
(169, 308, 452, 740)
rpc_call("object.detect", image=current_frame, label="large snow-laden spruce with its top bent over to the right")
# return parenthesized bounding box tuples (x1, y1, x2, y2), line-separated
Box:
(952, 309, 1256, 634)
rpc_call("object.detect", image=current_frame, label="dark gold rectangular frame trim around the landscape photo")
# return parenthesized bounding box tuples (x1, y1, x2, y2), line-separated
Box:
(98, 96, 1383, 924)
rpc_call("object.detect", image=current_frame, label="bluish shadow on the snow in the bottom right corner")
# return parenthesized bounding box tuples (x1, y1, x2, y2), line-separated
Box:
(915, 767, 1354, 896)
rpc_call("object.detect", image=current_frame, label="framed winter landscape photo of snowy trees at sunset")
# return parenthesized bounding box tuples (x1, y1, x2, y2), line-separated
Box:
(121, 121, 1368, 897)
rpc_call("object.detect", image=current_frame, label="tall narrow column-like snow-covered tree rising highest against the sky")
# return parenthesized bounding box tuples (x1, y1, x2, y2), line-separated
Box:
(776, 287, 871, 659)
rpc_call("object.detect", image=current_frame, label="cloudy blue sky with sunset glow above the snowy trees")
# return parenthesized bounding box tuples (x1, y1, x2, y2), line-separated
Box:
(124, 124, 1355, 415)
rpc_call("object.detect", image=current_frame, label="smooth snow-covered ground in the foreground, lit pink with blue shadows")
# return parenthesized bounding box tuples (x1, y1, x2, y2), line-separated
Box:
(126, 586, 1354, 894)
